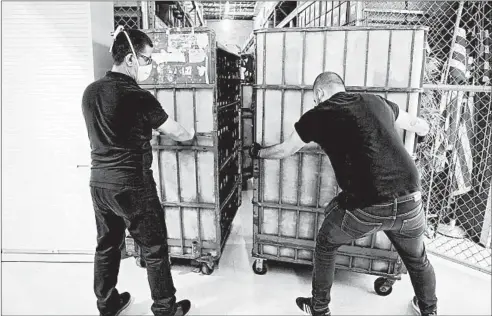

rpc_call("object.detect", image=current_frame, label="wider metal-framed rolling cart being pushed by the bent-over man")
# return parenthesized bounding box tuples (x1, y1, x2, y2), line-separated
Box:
(253, 27, 426, 279)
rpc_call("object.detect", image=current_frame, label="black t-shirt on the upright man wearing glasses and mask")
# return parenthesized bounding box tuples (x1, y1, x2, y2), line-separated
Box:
(82, 71, 168, 189)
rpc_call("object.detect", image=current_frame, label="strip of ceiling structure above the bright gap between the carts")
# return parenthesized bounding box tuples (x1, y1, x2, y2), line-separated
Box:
(201, 1, 260, 20)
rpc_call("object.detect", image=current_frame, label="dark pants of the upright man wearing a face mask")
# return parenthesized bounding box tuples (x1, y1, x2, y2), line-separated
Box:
(91, 180, 177, 316)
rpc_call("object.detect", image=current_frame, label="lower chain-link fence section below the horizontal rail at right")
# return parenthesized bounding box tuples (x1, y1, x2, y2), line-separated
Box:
(417, 86, 492, 272)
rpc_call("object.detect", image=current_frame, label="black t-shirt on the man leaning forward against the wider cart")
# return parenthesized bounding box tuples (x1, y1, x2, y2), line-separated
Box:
(295, 92, 420, 207)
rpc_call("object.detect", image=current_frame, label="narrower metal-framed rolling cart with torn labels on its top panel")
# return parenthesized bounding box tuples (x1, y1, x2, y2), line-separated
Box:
(134, 28, 242, 272)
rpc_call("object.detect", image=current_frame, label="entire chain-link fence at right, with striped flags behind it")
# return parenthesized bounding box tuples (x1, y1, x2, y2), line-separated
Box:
(358, 1, 492, 273)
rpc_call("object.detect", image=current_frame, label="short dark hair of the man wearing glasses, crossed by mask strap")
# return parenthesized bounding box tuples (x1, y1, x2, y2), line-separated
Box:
(111, 30, 154, 65)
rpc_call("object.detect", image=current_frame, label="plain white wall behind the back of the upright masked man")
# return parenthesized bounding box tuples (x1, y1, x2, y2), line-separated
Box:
(2, 1, 113, 260)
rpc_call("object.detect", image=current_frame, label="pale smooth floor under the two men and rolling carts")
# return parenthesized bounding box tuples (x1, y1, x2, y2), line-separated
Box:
(2, 192, 492, 315)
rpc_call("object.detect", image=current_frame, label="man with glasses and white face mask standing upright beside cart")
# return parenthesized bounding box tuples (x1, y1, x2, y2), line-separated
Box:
(82, 28, 194, 316)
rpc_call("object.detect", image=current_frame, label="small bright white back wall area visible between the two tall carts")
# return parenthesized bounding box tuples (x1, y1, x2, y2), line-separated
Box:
(207, 20, 253, 52)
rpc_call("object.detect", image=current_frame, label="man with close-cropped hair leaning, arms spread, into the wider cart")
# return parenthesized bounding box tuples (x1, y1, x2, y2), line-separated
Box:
(252, 72, 437, 315)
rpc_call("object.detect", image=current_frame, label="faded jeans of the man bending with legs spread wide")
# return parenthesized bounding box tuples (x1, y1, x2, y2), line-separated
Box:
(312, 192, 437, 315)
